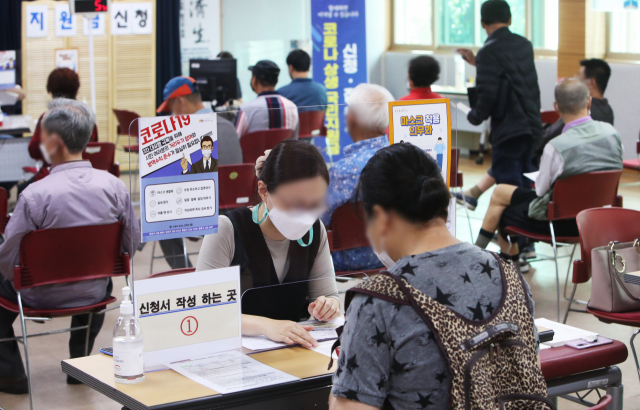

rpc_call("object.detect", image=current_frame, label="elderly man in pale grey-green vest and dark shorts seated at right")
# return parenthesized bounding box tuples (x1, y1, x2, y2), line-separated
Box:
(476, 78, 622, 273)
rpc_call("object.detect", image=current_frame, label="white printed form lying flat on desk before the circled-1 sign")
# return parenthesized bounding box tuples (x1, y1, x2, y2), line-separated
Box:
(166, 350, 299, 394)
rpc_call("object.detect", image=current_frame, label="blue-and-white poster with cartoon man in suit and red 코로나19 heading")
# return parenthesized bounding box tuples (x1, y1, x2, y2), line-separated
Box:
(139, 113, 218, 242)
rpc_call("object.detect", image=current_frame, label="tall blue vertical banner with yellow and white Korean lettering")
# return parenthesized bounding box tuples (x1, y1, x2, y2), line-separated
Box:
(311, 0, 367, 162)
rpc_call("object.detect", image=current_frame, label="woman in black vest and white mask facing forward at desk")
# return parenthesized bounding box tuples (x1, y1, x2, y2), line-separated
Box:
(197, 140, 340, 347)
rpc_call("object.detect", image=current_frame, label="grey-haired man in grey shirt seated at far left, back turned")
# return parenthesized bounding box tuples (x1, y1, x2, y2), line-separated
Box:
(0, 98, 140, 394)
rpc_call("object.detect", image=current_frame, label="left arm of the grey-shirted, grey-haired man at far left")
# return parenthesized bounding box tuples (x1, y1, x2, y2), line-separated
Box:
(0, 192, 36, 280)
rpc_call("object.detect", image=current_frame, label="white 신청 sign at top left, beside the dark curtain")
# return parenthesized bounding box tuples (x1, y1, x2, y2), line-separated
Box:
(111, 2, 153, 36)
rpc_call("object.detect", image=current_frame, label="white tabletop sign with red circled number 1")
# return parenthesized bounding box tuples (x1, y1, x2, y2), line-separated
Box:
(134, 266, 242, 370)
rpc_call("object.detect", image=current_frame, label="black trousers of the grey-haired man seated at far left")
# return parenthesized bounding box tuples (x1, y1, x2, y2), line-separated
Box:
(0, 276, 113, 378)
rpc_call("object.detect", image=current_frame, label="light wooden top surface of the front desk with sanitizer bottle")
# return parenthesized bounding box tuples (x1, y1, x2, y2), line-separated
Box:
(63, 347, 337, 407)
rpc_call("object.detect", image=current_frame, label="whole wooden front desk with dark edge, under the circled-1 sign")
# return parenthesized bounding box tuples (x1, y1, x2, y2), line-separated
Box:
(62, 347, 337, 410)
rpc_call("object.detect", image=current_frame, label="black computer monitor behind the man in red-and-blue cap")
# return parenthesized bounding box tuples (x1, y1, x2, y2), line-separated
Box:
(189, 59, 238, 106)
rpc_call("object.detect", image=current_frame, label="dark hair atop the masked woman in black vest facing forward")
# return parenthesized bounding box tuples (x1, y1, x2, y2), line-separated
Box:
(258, 140, 329, 192)
